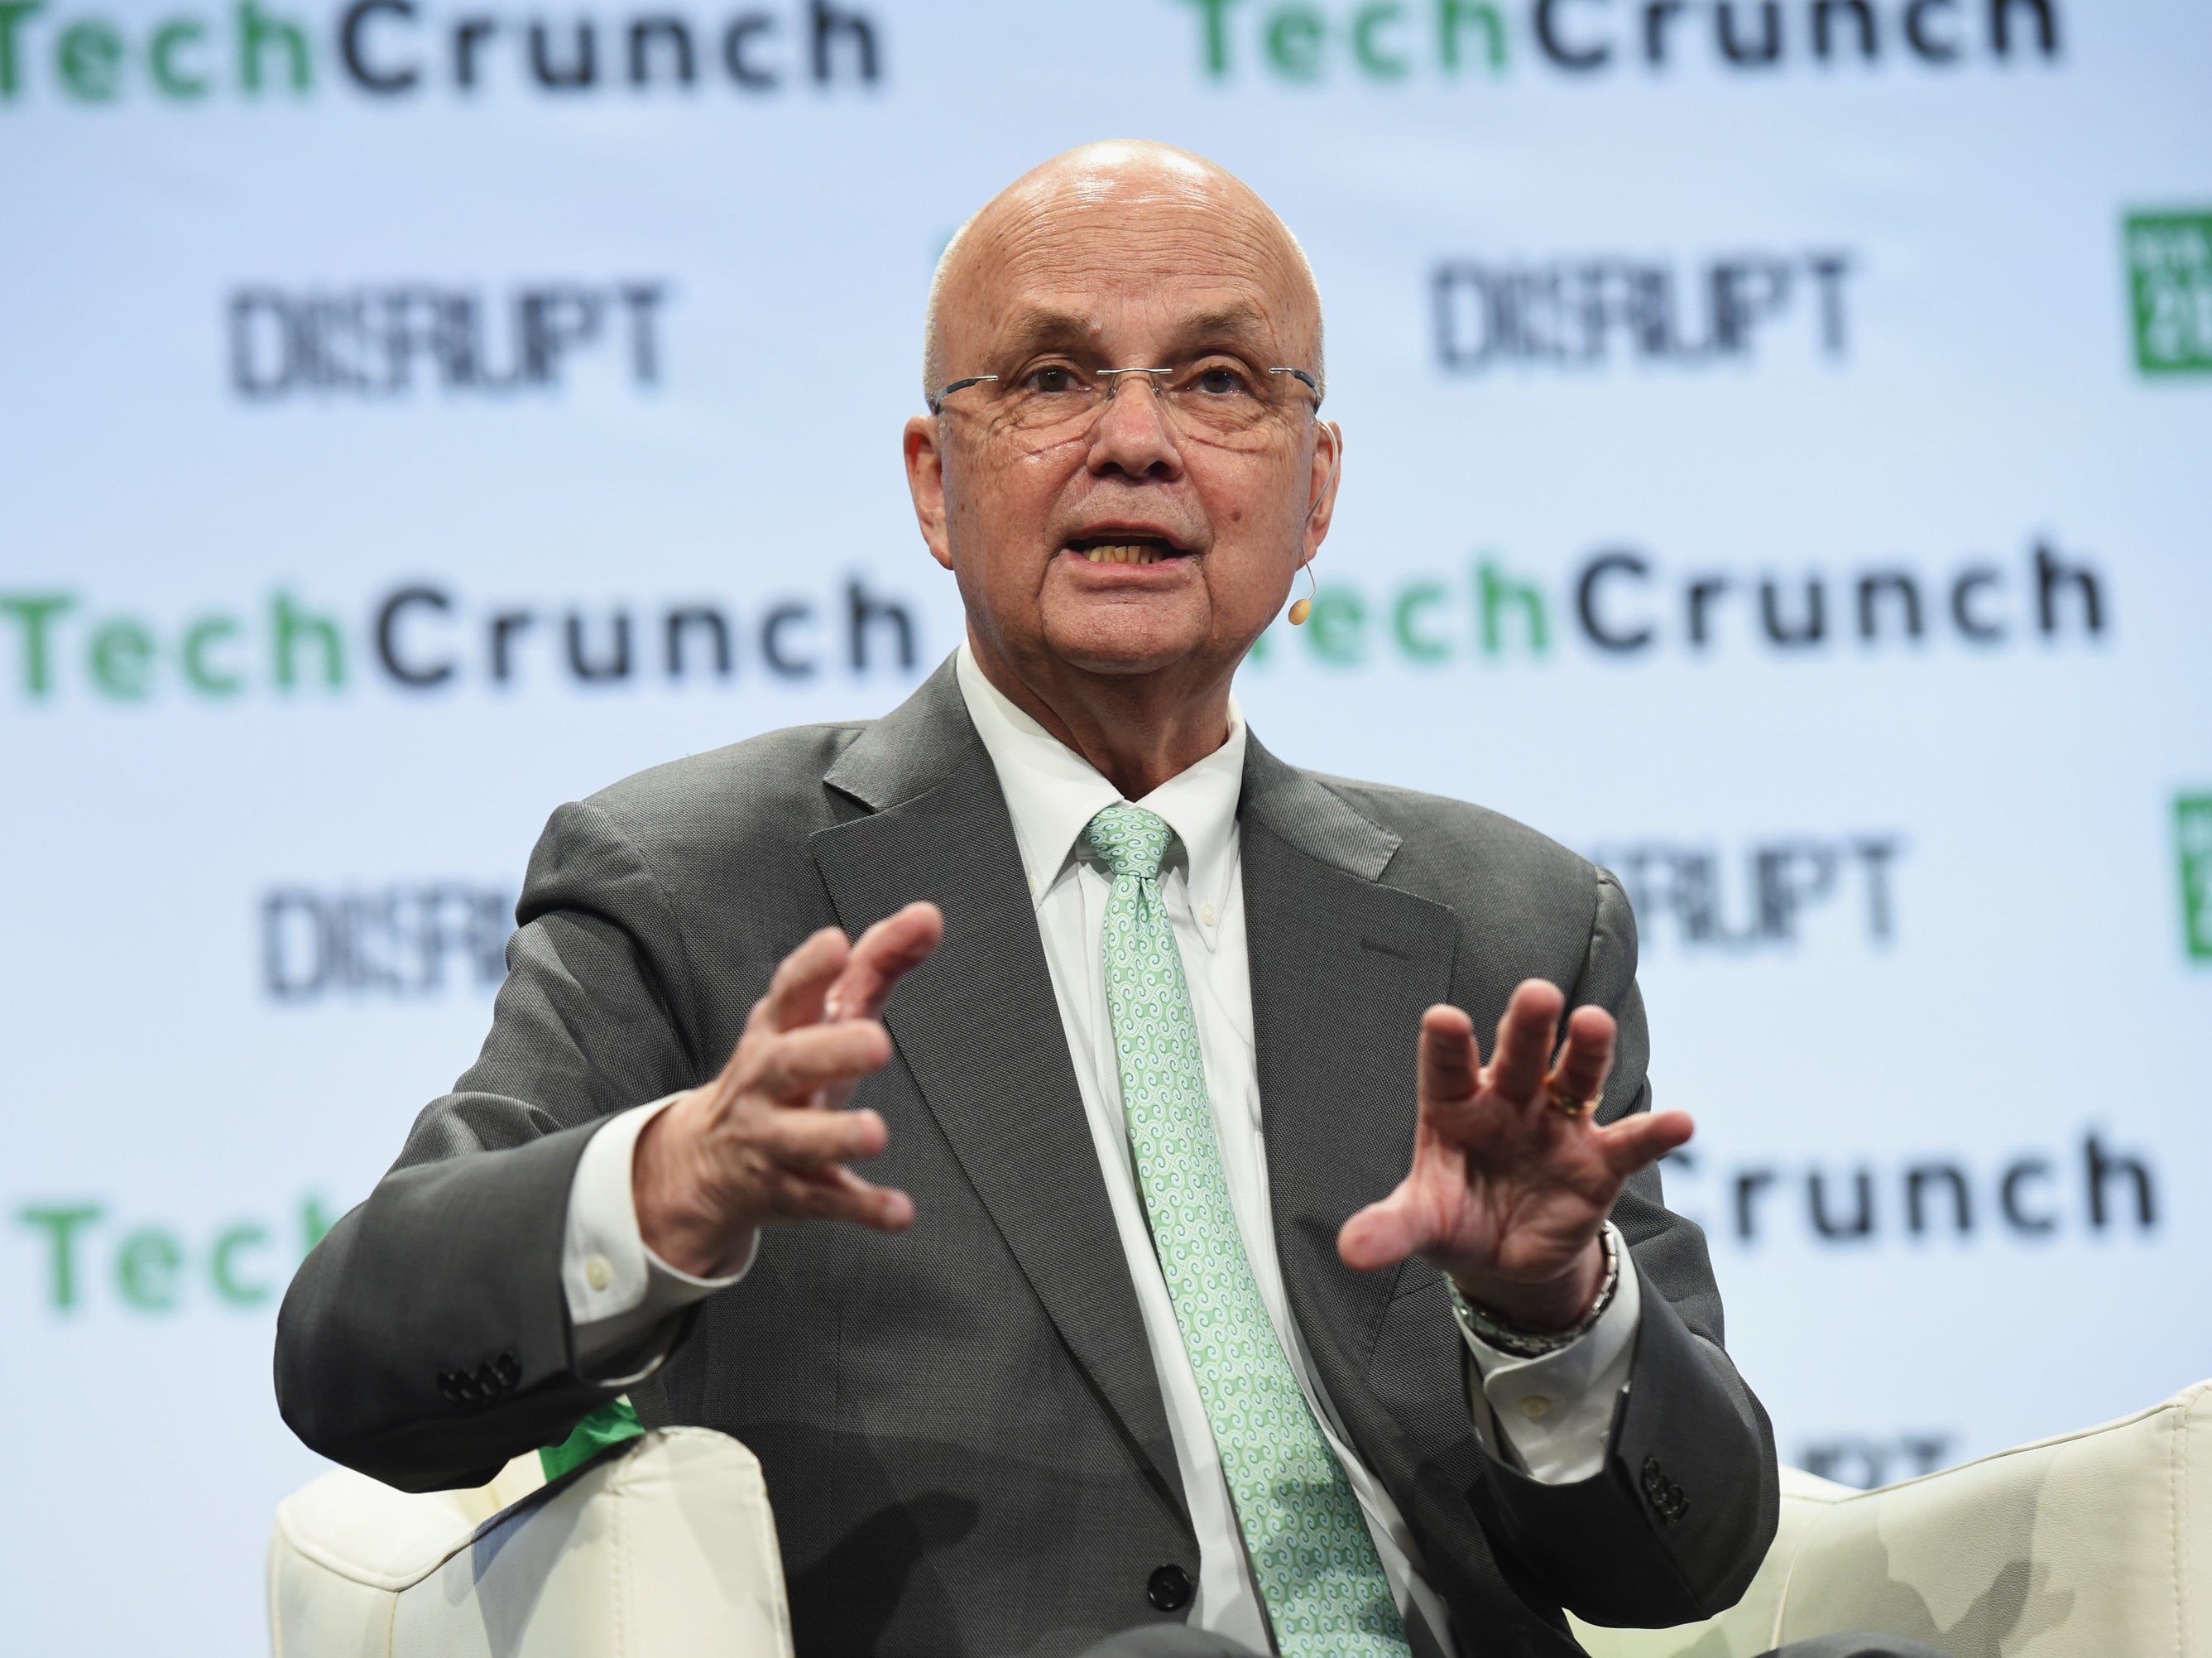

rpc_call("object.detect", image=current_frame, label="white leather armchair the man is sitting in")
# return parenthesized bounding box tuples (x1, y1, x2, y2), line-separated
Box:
(270, 1383, 2212, 1658)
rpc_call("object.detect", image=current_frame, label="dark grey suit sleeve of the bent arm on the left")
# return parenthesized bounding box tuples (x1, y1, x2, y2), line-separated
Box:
(276, 804, 703, 1490)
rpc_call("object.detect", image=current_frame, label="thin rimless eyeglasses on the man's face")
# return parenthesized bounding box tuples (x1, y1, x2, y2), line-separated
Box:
(929, 357, 1321, 449)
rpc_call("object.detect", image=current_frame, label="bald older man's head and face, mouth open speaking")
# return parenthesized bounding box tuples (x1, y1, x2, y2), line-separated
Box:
(907, 168, 1332, 677)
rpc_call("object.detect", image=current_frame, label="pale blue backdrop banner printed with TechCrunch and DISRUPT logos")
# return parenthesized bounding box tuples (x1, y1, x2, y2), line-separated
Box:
(0, 0, 2212, 1656)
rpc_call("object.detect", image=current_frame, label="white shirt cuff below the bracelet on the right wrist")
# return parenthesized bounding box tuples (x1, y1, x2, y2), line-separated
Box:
(1453, 1222, 1643, 1485)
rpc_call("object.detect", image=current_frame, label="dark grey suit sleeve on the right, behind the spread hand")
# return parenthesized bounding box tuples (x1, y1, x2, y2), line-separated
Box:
(1475, 872, 1781, 1629)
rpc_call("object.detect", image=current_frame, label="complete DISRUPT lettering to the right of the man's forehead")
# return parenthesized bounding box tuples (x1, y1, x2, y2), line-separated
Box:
(1429, 252, 1851, 374)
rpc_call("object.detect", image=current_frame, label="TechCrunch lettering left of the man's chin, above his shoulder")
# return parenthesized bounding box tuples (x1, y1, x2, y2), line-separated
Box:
(0, 575, 920, 706)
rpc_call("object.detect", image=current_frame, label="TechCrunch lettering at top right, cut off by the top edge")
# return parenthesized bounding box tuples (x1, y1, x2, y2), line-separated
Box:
(1183, 0, 2060, 84)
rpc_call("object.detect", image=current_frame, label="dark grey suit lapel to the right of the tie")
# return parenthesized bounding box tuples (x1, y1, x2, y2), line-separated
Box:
(1239, 742, 1458, 1381)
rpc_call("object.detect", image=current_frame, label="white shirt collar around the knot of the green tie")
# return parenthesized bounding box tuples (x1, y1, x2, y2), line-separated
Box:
(956, 642, 1245, 916)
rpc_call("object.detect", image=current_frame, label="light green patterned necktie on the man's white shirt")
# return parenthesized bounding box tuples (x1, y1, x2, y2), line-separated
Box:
(1084, 805, 1407, 1658)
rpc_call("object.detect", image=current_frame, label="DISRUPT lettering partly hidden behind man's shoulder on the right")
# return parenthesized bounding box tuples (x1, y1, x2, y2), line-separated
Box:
(1591, 834, 1904, 952)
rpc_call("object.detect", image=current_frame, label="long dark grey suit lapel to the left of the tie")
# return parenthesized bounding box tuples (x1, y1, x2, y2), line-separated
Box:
(812, 664, 1183, 1512)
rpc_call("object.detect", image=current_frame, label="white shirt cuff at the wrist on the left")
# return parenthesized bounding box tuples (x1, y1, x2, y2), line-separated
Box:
(559, 1093, 761, 1386)
